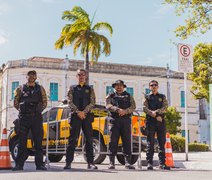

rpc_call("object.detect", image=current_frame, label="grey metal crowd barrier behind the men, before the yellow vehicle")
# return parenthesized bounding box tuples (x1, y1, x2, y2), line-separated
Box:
(46, 111, 142, 169)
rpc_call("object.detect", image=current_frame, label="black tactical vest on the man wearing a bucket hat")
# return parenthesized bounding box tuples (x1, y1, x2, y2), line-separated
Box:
(110, 91, 131, 118)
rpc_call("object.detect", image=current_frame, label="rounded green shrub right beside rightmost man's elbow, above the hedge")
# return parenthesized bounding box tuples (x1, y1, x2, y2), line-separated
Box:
(165, 106, 181, 134)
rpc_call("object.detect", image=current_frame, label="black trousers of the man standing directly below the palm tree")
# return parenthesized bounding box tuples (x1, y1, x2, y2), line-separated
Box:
(66, 113, 94, 164)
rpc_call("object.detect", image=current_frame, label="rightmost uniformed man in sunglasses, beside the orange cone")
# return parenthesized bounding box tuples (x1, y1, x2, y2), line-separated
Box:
(143, 80, 170, 170)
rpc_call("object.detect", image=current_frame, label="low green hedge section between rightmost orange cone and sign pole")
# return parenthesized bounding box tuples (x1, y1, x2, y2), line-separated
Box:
(171, 134, 185, 152)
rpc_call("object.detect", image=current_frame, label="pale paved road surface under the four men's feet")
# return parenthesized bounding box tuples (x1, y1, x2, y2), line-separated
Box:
(0, 152, 212, 180)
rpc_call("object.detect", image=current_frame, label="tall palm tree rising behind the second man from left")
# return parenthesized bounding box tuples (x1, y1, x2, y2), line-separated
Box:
(55, 6, 113, 83)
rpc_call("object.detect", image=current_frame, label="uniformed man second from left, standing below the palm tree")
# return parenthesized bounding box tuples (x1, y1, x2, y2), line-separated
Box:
(64, 69, 97, 170)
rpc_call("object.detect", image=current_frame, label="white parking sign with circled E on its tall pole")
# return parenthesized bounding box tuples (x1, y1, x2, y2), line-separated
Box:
(178, 44, 193, 161)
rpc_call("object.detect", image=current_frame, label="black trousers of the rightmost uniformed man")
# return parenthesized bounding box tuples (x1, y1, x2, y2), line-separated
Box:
(146, 121, 166, 165)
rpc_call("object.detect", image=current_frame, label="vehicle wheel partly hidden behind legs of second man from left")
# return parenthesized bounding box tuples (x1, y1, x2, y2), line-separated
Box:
(83, 138, 106, 164)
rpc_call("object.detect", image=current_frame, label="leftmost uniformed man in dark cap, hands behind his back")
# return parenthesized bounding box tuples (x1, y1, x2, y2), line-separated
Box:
(13, 70, 47, 171)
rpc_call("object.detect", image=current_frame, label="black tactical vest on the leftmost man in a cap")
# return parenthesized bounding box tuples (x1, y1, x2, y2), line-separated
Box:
(20, 83, 42, 113)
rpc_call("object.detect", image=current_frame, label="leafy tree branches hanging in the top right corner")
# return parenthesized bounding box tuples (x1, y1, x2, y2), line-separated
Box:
(165, 0, 212, 39)
